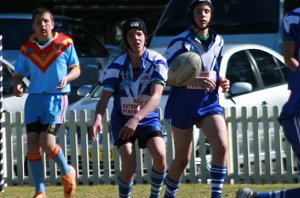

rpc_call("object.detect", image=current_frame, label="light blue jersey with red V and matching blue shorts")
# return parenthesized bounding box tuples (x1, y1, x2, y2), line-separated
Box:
(14, 33, 79, 124)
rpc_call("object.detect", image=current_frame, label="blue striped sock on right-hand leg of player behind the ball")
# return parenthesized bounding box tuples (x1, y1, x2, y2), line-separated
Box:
(210, 165, 227, 198)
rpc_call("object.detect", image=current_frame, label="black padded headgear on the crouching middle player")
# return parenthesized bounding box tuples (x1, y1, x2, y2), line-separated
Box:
(122, 18, 148, 48)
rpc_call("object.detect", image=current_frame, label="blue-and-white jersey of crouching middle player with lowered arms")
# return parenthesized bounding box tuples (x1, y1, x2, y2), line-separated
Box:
(100, 49, 168, 125)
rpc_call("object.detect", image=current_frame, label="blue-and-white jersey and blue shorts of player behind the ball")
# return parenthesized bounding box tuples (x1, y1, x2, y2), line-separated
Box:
(165, 28, 224, 128)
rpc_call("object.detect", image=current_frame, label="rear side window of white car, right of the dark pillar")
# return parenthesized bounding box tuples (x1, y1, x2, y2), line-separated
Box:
(249, 49, 287, 86)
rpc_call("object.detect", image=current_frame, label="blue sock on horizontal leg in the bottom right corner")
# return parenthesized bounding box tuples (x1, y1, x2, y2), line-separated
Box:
(255, 188, 300, 198)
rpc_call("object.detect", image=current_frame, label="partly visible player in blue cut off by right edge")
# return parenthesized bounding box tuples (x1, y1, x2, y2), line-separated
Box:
(237, 5, 300, 198)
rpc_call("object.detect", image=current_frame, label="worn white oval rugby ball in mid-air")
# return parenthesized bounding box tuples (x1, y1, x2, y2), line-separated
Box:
(167, 52, 202, 87)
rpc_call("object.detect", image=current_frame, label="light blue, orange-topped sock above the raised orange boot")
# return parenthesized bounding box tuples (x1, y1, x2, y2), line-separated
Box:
(47, 145, 71, 175)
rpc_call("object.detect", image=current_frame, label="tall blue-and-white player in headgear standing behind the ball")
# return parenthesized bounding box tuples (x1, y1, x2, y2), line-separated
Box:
(165, 0, 229, 198)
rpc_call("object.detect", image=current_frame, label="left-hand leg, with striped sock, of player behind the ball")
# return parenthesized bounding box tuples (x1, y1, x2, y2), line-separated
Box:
(165, 127, 193, 198)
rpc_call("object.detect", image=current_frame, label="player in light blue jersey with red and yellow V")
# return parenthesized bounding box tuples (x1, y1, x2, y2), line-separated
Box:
(13, 8, 80, 198)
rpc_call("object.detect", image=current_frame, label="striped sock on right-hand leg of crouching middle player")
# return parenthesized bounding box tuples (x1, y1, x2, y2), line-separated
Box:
(150, 168, 165, 198)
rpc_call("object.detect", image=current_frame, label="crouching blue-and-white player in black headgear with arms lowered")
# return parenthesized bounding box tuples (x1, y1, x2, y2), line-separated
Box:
(92, 18, 168, 198)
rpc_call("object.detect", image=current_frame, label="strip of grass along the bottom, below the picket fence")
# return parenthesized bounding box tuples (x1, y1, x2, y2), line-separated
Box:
(0, 184, 299, 198)
